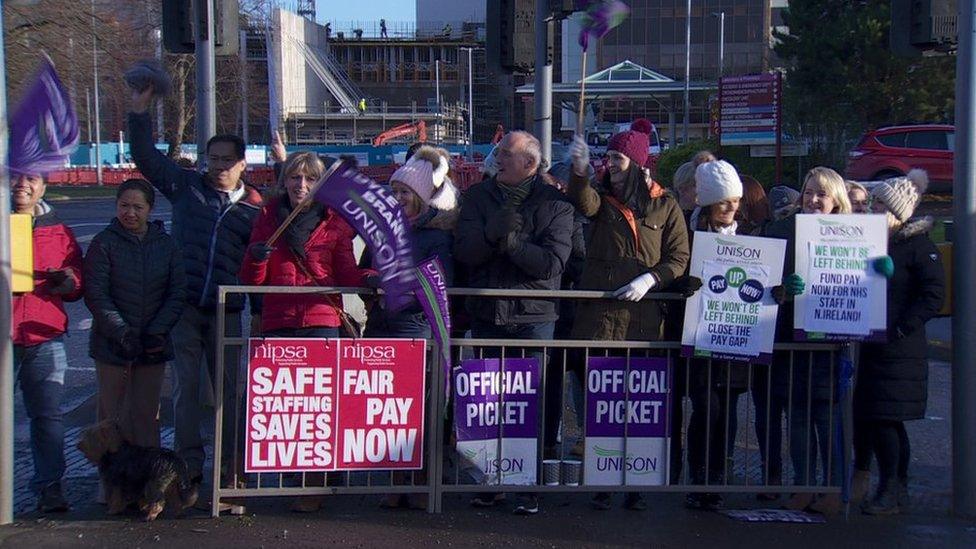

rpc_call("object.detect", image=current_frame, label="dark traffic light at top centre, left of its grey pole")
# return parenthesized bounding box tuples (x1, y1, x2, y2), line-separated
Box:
(485, 0, 535, 72)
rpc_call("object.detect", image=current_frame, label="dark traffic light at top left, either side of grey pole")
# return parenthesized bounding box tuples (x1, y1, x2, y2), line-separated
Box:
(162, 0, 240, 55)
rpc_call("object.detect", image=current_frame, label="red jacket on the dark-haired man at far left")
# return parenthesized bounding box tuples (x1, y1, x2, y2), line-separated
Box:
(11, 203, 84, 346)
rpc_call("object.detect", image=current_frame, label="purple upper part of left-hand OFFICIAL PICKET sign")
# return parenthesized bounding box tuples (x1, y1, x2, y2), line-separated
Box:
(454, 358, 539, 442)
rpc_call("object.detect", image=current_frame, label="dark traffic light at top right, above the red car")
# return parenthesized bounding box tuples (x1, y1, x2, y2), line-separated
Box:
(889, 0, 959, 56)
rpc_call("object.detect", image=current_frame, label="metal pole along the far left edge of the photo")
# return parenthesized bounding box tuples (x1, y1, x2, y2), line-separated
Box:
(0, 4, 14, 524)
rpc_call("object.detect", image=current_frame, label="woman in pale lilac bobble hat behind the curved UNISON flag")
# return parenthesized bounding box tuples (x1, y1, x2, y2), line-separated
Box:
(363, 146, 458, 509)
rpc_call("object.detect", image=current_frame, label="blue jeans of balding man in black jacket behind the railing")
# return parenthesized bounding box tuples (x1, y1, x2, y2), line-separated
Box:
(471, 319, 563, 446)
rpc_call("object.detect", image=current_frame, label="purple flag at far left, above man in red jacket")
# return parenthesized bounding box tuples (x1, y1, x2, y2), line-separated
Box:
(8, 56, 78, 174)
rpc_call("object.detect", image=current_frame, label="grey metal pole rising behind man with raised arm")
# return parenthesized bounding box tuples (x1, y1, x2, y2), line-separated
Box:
(193, 0, 217, 167)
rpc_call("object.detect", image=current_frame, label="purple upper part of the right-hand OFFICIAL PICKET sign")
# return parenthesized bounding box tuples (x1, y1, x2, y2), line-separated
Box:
(586, 357, 670, 437)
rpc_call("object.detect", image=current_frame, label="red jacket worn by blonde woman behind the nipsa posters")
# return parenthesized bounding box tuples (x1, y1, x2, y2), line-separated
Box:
(240, 199, 373, 331)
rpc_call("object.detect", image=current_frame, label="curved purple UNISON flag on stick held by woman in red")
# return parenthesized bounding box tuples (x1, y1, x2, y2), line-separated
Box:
(315, 162, 417, 312)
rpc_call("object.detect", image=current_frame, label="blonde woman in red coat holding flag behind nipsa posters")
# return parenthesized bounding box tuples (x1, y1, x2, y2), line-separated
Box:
(240, 152, 375, 337)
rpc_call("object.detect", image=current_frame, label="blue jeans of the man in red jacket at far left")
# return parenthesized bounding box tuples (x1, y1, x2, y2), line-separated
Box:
(14, 337, 68, 492)
